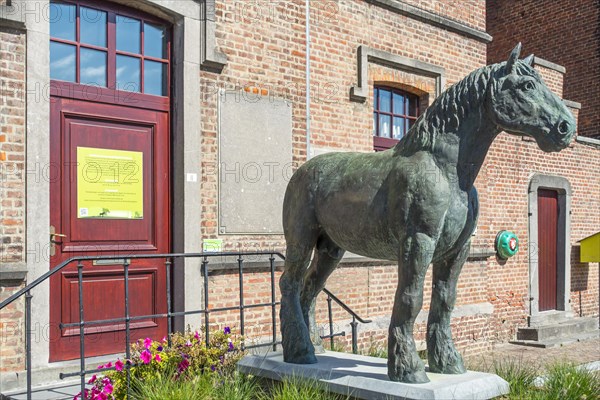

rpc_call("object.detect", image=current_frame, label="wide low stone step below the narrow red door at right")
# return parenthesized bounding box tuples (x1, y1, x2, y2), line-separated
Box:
(517, 317, 598, 342)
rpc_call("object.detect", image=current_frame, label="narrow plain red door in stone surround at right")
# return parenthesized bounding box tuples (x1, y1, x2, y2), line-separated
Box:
(538, 189, 558, 311)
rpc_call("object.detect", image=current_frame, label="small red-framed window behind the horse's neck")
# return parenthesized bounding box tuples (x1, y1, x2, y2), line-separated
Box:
(373, 86, 419, 151)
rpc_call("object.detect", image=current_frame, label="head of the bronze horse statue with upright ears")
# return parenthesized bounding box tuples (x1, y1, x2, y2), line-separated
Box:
(486, 43, 576, 152)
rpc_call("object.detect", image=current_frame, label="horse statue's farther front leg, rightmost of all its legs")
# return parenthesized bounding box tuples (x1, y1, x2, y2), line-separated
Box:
(427, 241, 471, 374)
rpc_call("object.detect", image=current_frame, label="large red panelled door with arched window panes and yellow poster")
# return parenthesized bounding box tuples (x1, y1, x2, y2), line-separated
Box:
(50, 1, 171, 361)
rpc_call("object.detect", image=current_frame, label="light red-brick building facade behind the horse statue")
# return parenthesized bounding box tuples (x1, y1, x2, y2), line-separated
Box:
(0, 0, 600, 378)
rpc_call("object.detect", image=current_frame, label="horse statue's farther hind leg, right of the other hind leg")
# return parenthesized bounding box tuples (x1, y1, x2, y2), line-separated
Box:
(300, 234, 345, 347)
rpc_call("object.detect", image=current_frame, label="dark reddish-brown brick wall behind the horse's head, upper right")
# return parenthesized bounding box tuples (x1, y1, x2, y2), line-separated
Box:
(487, 0, 600, 137)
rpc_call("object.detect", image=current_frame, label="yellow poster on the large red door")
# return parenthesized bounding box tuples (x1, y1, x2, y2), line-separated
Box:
(77, 147, 144, 219)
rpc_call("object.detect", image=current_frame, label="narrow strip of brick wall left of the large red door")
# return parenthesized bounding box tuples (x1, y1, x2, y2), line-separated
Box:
(0, 26, 25, 371)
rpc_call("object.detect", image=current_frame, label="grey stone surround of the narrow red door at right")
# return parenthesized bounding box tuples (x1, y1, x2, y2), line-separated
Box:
(528, 174, 572, 325)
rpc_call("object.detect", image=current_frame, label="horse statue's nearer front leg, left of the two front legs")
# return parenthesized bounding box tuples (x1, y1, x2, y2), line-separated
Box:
(388, 234, 435, 383)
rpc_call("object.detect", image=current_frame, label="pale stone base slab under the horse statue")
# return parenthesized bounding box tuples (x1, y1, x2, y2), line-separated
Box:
(238, 351, 509, 400)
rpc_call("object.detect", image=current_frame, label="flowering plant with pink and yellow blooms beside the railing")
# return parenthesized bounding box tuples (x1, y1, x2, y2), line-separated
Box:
(74, 326, 244, 400)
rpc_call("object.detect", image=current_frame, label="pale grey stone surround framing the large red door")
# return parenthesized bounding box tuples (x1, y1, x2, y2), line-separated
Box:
(24, 0, 206, 370)
